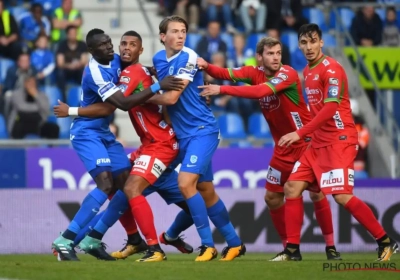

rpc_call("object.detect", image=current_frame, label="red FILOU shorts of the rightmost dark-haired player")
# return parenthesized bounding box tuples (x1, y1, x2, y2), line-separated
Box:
(288, 143, 358, 195)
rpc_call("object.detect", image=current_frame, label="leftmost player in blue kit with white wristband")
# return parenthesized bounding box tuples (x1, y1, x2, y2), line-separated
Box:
(52, 29, 183, 261)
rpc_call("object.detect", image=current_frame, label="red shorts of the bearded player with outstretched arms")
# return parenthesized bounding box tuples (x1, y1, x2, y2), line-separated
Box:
(265, 145, 308, 193)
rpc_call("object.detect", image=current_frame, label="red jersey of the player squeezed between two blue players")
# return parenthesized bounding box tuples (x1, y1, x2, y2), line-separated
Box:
(118, 63, 175, 145)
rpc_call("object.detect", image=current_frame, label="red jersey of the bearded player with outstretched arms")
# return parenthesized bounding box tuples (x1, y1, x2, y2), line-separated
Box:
(227, 65, 311, 147)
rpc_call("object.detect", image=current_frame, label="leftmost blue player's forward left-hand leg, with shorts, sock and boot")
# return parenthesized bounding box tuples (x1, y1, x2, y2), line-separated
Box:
(52, 136, 113, 260)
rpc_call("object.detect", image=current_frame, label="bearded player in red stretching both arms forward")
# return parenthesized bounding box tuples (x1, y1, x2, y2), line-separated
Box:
(197, 37, 340, 260)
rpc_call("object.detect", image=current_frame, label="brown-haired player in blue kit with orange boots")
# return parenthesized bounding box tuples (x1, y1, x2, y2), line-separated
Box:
(149, 16, 246, 261)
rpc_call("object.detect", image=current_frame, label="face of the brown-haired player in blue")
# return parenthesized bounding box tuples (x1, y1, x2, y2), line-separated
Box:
(160, 21, 186, 53)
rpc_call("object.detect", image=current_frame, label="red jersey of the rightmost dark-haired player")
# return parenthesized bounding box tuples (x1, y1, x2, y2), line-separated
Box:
(303, 56, 358, 148)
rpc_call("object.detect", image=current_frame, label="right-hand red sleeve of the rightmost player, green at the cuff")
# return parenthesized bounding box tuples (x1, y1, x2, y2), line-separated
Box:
(322, 64, 345, 103)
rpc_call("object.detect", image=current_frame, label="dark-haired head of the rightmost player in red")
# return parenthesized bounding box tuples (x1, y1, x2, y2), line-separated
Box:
(297, 23, 324, 62)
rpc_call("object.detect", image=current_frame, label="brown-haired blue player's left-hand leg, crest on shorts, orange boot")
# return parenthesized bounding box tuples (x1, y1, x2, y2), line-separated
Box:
(178, 135, 219, 261)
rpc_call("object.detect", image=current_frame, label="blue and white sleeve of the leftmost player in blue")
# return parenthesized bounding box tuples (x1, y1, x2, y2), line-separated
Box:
(88, 68, 119, 101)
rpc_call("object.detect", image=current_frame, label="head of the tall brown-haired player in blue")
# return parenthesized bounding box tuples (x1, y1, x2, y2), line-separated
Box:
(159, 16, 188, 52)
